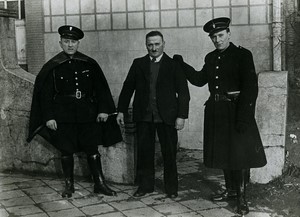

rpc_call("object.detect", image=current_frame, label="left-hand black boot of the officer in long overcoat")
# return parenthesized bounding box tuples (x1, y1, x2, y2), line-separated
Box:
(212, 170, 237, 201)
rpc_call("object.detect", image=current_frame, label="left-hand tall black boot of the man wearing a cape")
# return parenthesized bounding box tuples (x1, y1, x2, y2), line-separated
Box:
(61, 155, 75, 197)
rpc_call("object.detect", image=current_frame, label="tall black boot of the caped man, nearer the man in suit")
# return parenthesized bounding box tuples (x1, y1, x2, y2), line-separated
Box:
(87, 154, 117, 196)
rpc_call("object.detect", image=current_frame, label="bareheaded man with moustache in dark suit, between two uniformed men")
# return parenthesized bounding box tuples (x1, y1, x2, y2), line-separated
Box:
(117, 31, 190, 198)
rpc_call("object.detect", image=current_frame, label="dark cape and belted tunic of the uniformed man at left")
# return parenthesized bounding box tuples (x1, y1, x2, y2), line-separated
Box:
(27, 52, 122, 145)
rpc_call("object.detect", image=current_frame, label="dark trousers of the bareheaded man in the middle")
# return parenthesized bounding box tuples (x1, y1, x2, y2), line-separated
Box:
(137, 122, 178, 194)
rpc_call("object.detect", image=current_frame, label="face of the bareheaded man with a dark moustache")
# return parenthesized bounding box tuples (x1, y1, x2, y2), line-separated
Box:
(146, 35, 165, 57)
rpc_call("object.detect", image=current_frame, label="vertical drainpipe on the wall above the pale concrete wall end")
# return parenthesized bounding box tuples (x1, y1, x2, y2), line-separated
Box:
(272, 0, 282, 71)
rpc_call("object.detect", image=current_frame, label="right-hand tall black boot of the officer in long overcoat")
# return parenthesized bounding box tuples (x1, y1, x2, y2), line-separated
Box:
(236, 169, 250, 216)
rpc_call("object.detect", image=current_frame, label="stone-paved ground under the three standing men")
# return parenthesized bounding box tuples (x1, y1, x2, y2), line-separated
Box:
(0, 150, 279, 217)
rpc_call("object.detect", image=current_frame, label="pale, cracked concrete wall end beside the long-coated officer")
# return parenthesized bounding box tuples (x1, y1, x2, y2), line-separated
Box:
(251, 71, 288, 183)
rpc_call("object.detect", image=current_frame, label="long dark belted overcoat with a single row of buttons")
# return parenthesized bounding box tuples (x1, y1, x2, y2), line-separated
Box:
(183, 43, 266, 170)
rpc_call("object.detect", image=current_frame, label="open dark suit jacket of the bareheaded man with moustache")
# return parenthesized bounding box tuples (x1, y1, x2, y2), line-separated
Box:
(118, 53, 190, 125)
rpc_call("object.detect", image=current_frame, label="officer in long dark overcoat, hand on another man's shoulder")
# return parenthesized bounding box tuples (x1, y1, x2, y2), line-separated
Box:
(174, 17, 266, 215)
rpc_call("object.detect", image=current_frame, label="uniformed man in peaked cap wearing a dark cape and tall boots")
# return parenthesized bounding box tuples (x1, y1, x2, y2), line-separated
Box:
(28, 25, 121, 197)
